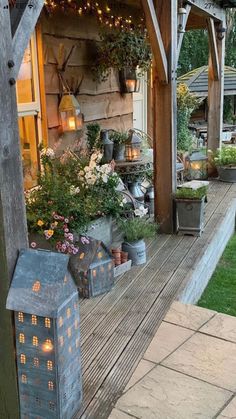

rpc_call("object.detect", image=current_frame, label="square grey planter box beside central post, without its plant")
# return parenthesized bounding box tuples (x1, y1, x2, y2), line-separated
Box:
(175, 197, 205, 236)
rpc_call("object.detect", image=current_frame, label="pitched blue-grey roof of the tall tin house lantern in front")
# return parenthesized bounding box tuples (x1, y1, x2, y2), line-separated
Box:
(6, 249, 78, 318)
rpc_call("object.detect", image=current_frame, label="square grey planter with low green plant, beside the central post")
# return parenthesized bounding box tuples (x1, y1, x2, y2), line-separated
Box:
(175, 181, 208, 236)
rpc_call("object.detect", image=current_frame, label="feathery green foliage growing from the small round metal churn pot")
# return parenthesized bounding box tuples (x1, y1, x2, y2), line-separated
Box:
(119, 217, 157, 243)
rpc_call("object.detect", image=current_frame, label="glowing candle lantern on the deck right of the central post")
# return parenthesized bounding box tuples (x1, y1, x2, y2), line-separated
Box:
(186, 151, 208, 180)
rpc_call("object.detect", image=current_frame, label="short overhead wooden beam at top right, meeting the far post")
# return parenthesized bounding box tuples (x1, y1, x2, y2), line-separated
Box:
(187, 0, 225, 21)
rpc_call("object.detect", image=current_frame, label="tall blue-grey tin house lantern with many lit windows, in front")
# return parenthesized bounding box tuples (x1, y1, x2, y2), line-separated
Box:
(7, 250, 82, 419)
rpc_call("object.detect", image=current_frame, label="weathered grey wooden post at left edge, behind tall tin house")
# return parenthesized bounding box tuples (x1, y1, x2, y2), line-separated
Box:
(0, 4, 28, 419)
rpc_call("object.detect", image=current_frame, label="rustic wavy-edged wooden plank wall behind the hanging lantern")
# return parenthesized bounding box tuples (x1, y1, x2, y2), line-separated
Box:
(40, 13, 133, 153)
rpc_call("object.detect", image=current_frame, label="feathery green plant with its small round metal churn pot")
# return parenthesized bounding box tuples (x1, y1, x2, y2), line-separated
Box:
(119, 206, 157, 266)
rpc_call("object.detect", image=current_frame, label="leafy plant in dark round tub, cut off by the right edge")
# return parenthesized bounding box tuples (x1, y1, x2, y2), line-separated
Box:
(213, 146, 236, 182)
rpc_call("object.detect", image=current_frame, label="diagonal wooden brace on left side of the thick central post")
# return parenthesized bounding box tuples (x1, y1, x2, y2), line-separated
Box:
(141, 0, 168, 83)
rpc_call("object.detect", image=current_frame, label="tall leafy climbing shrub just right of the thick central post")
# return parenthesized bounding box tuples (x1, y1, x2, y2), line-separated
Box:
(177, 83, 200, 151)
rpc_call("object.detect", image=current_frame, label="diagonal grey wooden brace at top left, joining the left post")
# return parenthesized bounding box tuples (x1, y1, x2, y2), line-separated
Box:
(13, 0, 44, 79)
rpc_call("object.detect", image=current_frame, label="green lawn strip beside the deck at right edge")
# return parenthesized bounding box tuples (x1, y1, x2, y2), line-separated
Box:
(197, 235, 236, 316)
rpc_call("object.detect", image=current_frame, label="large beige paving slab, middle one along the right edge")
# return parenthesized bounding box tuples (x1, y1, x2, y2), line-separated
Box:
(163, 333, 236, 392)
